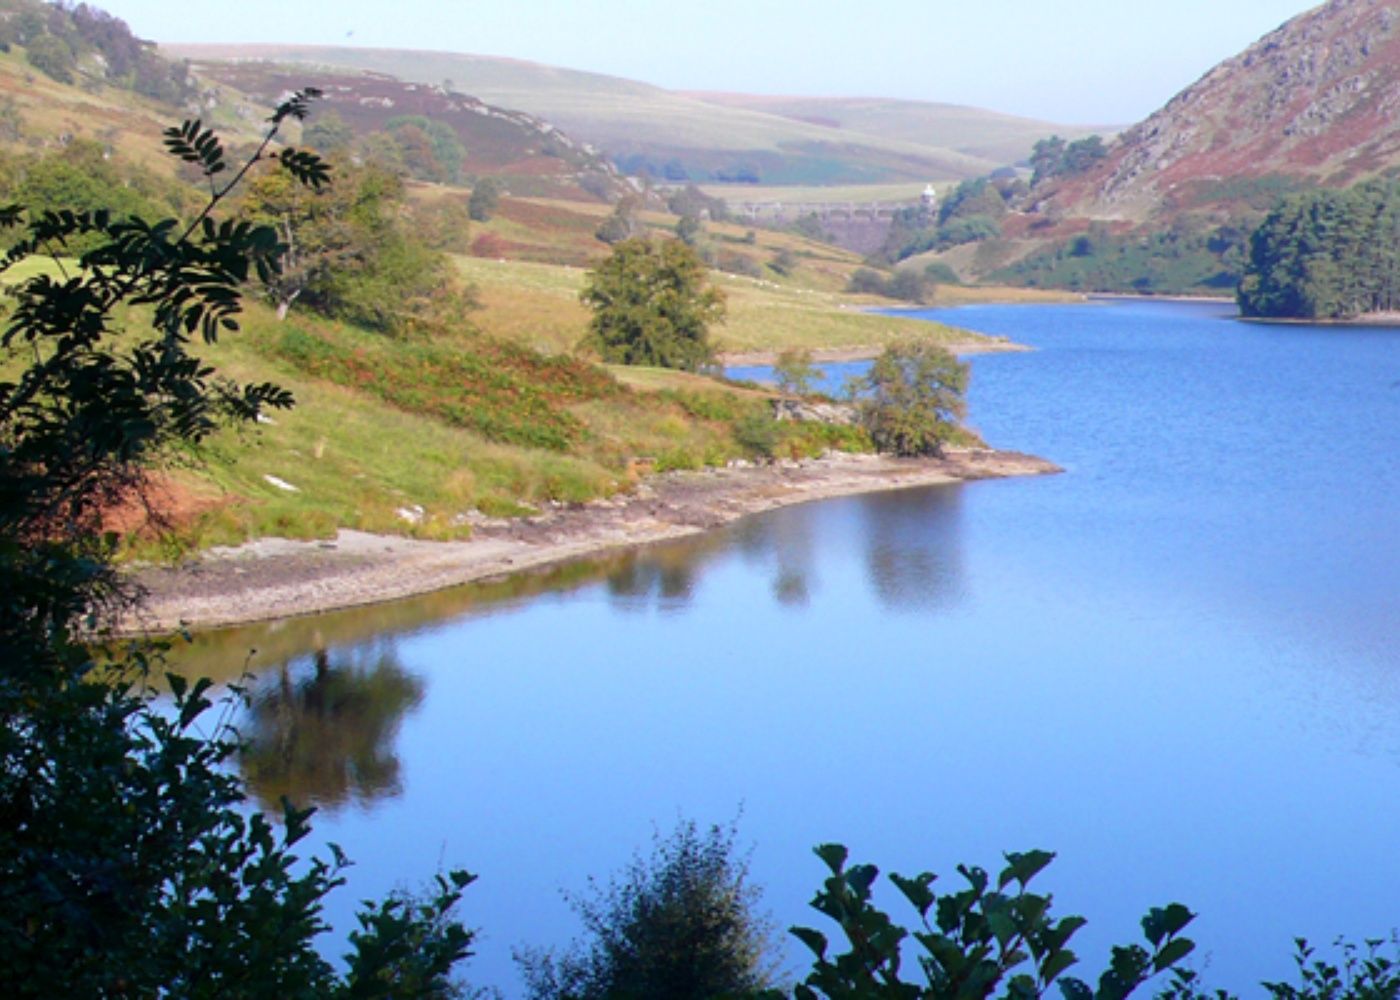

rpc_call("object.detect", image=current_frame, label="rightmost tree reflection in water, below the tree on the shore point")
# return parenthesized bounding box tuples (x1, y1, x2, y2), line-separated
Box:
(862, 486, 966, 612)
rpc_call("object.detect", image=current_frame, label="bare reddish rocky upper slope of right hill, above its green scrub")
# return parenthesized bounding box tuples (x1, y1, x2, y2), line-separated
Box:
(1036, 0, 1400, 223)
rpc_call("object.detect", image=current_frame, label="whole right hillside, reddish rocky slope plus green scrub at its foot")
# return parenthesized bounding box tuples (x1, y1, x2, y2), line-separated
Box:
(896, 0, 1400, 296)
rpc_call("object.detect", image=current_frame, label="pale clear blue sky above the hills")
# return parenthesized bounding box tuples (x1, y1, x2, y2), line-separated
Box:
(97, 0, 1316, 125)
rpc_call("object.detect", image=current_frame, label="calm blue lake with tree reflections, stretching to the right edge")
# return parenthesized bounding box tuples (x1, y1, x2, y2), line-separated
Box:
(175, 301, 1400, 994)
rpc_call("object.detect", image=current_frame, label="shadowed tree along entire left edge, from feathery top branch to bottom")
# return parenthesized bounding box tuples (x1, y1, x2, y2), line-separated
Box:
(0, 91, 472, 999)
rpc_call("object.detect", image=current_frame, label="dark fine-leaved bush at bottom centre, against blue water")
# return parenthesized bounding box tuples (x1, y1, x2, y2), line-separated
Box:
(517, 821, 777, 1000)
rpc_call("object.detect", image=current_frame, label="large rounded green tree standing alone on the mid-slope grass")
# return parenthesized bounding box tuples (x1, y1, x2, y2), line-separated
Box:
(580, 239, 725, 371)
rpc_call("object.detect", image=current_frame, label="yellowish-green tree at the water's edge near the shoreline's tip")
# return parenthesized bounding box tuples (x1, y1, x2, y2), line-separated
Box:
(853, 340, 967, 455)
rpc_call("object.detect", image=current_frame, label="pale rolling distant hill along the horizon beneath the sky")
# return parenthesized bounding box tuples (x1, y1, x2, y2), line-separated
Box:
(162, 45, 1085, 185)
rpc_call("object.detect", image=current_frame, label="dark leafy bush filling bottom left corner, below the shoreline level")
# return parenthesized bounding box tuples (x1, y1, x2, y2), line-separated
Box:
(0, 647, 473, 997)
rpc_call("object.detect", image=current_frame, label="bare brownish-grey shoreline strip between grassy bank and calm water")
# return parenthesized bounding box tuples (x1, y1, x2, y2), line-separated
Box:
(119, 450, 1063, 636)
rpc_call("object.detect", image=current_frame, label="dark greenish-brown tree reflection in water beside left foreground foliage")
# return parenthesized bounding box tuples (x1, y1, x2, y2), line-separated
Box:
(241, 646, 424, 812)
